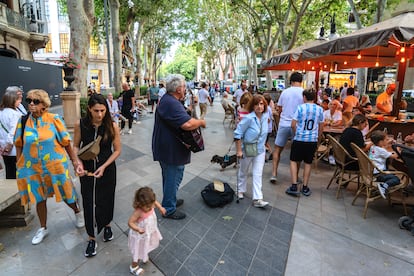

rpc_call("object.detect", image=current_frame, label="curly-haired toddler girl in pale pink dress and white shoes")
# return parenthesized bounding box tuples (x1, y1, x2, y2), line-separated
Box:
(128, 187, 166, 275)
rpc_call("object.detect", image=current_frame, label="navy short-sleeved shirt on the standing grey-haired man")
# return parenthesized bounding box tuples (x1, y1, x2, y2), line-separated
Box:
(152, 93, 191, 166)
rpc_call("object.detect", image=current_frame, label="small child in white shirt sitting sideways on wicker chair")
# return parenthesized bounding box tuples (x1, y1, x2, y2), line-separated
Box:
(369, 130, 400, 198)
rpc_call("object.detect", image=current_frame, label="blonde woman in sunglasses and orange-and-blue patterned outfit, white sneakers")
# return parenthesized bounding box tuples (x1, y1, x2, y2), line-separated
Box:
(14, 89, 84, 244)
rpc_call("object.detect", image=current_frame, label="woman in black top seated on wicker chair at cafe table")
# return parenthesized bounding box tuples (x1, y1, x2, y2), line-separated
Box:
(339, 114, 371, 170)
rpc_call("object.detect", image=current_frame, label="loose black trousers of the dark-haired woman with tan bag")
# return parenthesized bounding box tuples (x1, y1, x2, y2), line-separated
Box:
(81, 169, 116, 237)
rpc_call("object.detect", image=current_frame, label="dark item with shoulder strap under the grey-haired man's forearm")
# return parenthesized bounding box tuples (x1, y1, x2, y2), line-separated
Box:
(156, 111, 204, 152)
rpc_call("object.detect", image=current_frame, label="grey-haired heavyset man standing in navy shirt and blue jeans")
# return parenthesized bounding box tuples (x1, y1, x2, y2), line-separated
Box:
(152, 75, 206, 219)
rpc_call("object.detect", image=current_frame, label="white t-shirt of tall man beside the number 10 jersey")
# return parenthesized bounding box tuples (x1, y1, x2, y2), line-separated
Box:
(277, 86, 303, 127)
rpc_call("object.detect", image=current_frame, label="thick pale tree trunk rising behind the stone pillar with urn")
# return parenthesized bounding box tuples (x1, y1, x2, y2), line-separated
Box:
(67, 0, 95, 97)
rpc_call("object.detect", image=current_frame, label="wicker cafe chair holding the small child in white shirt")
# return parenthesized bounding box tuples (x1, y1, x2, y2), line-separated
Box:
(351, 143, 408, 218)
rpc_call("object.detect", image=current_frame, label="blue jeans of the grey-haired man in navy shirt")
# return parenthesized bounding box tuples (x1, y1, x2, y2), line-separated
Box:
(160, 161, 184, 216)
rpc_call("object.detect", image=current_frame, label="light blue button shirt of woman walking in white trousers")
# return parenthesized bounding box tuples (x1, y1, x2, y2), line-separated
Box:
(234, 111, 269, 154)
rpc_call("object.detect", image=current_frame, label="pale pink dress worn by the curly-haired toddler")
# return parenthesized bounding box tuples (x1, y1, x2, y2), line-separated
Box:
(128, 208, 162, 262)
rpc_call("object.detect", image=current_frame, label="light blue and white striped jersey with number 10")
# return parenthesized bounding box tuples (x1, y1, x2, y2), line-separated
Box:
(293, 103, 323, 142)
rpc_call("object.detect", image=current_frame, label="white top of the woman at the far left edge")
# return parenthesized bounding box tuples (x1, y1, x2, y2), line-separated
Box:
(0, 107, 22, 156)
